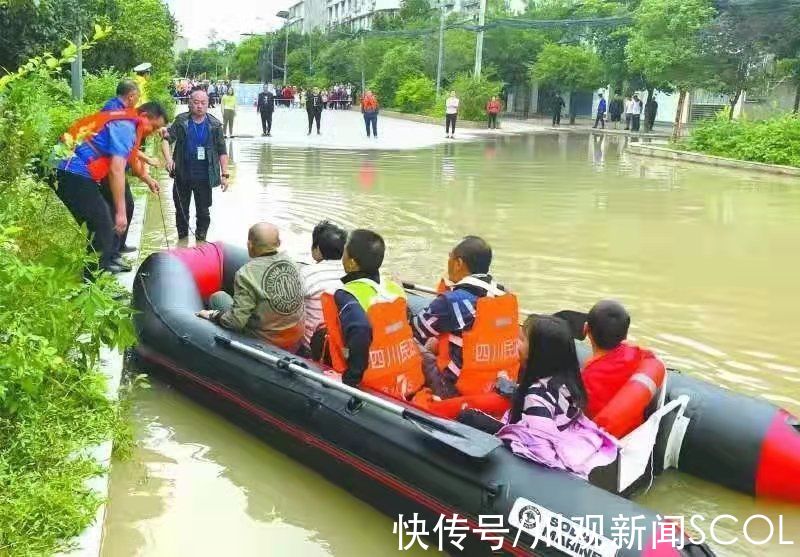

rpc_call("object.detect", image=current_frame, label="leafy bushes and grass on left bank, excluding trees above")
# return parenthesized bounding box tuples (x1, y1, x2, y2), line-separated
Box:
(0, 38, 134, 555)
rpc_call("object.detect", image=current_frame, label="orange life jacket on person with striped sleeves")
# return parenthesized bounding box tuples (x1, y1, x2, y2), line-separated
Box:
(436, 277, 519, 395)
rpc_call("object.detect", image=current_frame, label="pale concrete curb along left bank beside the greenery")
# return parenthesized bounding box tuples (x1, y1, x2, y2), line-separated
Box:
(57, 188, 149, 557)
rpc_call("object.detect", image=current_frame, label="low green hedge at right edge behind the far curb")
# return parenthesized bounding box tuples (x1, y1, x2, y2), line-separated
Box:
(682, 114, 800, 167)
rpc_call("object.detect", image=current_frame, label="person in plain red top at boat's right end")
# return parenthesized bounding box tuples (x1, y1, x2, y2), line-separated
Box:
(582, 300, 656, 418)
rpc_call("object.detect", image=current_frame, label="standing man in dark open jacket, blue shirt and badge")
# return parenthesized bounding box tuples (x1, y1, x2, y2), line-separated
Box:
(161, 89, 230, 242)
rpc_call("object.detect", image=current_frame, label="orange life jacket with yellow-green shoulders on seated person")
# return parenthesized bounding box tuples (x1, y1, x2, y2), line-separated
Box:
(322, 279, 425, 399)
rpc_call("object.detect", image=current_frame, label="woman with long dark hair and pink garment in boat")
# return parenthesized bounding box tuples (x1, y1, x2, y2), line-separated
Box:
(497, 316, 619, 479)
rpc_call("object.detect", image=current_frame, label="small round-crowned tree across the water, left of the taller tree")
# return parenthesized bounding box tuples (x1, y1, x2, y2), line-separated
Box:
(530, 44, 603, 124)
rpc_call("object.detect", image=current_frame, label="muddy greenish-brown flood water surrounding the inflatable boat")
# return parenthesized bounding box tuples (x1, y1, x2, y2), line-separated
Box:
(104, 133, 800, 557)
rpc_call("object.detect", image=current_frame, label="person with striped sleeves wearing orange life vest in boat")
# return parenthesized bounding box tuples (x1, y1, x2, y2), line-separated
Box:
(412, 236, 519, 398)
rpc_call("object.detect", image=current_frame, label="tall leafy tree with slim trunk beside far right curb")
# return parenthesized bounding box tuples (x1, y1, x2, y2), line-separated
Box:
(625, 0, 714, 139)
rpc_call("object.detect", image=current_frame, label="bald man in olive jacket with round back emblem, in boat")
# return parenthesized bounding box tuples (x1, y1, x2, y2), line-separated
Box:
(197, 222, 304, 352)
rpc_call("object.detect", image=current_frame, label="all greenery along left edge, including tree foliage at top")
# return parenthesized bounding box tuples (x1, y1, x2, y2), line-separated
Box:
(0, 0, 174, 555)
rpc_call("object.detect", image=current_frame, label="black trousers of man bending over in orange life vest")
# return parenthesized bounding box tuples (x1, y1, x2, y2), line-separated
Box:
(56, 170, 117, 271)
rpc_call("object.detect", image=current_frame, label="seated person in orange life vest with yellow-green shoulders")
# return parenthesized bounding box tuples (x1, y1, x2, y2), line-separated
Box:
(322, 229, 424, 398)
